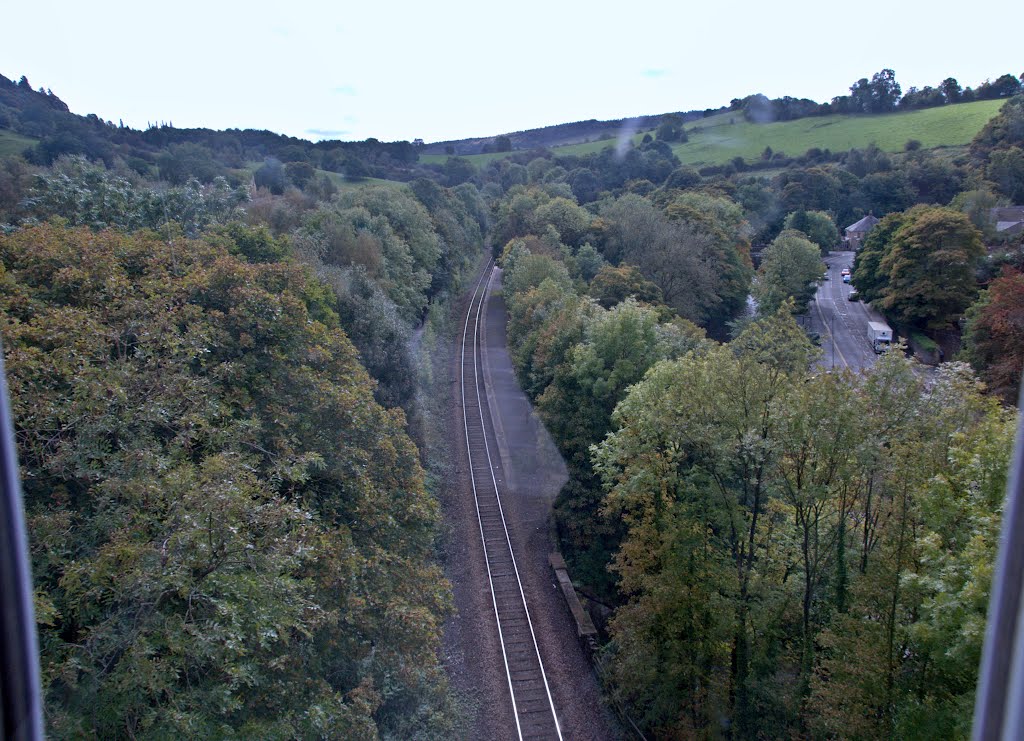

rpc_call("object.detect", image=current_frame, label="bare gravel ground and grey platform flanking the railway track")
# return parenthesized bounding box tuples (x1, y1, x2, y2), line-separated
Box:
(442, 270, 621, 739)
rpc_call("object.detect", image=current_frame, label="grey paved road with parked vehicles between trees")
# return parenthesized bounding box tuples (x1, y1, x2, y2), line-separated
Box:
(809, 252, 884, 371)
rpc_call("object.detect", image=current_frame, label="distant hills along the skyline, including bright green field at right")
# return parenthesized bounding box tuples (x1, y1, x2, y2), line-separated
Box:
(0, 69, 1021, 184)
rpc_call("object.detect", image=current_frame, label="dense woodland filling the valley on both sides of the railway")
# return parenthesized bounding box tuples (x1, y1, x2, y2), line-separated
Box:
(0, 71, 1024, 738)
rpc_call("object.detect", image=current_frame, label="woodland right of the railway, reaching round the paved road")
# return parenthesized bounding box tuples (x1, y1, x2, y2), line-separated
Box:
(485, 91, 1024, 739)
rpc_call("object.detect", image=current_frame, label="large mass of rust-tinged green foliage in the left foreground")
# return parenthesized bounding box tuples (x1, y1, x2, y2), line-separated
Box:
(0, 225, 451, 738)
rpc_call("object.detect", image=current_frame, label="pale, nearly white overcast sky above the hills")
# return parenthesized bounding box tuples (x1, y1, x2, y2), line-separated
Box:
(0, 0, 1024, 142)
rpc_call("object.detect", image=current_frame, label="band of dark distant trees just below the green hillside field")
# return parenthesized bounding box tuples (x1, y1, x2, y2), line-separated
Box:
(458, 101, 1024, 245)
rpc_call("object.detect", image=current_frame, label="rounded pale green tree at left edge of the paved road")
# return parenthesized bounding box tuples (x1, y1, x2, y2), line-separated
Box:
(754, 229, 822, 315)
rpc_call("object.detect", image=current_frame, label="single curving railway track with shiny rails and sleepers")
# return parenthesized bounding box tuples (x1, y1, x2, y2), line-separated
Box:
(459, 261, 562, 739)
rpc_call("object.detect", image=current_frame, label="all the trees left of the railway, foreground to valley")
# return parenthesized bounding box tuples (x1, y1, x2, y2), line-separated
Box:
(0, 104, 488, 738)
